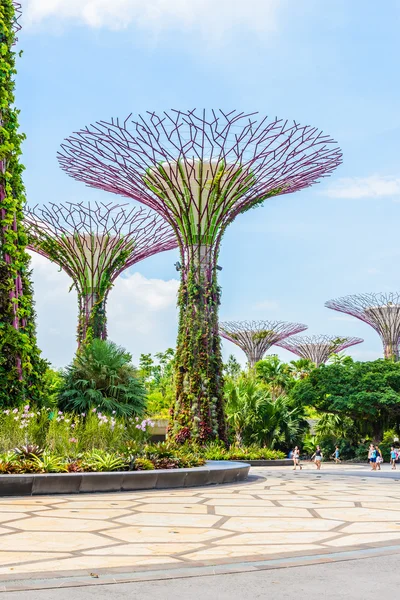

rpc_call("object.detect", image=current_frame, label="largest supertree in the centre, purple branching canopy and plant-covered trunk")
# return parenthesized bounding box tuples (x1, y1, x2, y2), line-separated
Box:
(59, 110, 341, 442)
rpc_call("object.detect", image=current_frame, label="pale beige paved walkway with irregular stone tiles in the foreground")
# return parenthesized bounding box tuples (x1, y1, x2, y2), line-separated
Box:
(0, 465, 400, 590)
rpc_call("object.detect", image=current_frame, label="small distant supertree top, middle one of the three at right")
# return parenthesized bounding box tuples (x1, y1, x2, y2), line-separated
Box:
(277, 335, 364, 367)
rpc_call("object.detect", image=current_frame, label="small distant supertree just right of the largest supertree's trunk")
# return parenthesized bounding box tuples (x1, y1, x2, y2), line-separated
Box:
(219, 321, 307, 367)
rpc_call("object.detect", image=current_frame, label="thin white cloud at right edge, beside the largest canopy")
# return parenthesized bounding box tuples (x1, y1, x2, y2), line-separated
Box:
(324, 175, 400, 199)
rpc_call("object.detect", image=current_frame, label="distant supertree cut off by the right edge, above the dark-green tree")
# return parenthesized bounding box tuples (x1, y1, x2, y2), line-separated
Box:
(325, 292, 400, 361)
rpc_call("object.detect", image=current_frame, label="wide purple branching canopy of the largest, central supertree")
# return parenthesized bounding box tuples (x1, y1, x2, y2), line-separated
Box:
(58, 110, 342, 246)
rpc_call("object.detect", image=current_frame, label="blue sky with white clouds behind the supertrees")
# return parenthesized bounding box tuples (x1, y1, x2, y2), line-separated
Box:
(17, 0, 400, 366)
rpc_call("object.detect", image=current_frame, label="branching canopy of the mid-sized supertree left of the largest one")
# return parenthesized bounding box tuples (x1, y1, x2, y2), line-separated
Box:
(25, 202, 177, 281)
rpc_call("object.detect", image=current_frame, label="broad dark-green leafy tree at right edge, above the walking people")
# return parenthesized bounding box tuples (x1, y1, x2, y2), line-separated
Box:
(291, 360, 400, 442)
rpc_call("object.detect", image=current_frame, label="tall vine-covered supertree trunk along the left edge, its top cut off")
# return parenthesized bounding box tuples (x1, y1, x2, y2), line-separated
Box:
(0, 0, 47, 405)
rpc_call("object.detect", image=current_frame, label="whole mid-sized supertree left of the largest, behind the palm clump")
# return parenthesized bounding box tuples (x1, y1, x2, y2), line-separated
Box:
(25, 202, 177, 345)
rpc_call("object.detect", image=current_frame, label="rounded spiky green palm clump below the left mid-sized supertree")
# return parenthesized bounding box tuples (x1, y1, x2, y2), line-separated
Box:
(59, 338, 146, 416)
